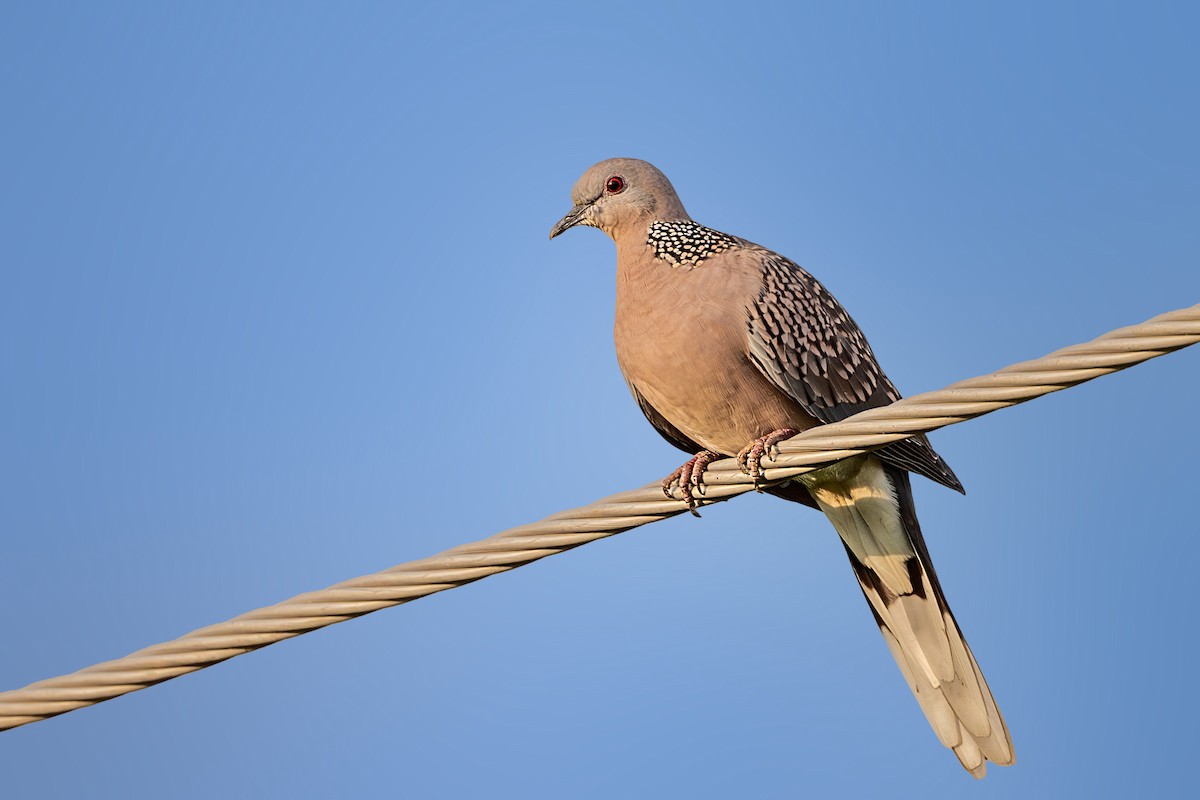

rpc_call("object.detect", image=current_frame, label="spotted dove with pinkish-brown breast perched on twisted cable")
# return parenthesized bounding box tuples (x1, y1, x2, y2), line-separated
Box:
(550, 158, 1013, 777)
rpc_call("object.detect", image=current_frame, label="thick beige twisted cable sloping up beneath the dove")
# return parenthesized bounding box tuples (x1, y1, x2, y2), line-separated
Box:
(0, 305, 1200, 730)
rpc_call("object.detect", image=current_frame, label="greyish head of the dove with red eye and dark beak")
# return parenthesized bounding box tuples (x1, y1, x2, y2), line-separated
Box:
(550, 158, 690, 239)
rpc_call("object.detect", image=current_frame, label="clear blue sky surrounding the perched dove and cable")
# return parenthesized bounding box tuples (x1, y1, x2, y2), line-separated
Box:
(0, 2, 1200, 798)
